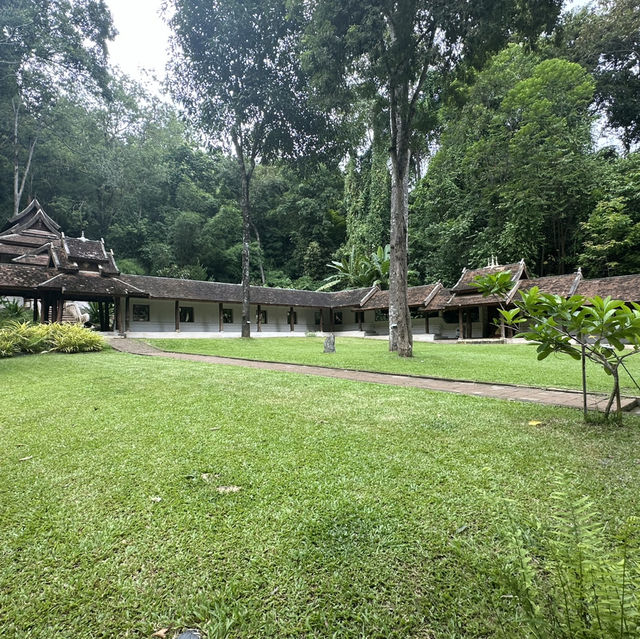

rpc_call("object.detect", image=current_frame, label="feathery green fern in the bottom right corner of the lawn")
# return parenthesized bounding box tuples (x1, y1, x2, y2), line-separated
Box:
(507, 492, 640, 639)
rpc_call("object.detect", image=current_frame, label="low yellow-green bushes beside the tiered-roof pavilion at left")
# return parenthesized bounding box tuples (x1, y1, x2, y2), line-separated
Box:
(0, 322, 104, 357)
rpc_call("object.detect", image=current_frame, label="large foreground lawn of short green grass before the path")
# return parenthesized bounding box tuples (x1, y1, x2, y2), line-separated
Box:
(0, 352, 640, 639)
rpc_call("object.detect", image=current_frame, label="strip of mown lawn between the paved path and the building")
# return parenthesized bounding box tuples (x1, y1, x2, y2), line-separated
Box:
(147, 336, 640, 395)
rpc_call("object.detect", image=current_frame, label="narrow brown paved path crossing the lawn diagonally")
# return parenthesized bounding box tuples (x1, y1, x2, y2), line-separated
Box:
(109, 338, 636, 411)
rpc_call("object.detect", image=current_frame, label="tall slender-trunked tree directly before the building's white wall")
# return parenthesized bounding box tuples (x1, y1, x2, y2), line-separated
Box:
(169, 0, 336, 337)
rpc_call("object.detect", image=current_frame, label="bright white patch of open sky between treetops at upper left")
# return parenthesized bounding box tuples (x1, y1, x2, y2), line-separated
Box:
(107, 0, 170, 84)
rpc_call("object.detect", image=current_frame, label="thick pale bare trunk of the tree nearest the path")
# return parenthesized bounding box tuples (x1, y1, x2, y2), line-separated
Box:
(389, 84, 413, 357)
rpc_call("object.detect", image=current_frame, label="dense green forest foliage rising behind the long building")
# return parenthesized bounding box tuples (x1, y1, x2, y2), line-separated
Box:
(0, 0, 640, 288)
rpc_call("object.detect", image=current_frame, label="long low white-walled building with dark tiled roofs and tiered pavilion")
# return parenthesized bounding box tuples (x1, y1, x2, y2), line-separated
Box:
(0, 200, 640, 339)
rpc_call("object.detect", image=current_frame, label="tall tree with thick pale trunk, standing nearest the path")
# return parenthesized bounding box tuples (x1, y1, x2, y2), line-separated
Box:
(301, 0, 561, 357)
